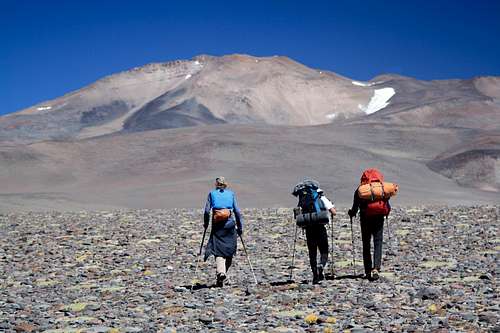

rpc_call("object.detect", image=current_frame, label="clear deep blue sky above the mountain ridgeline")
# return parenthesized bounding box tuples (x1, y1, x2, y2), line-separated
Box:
(0, 0, 500, 114)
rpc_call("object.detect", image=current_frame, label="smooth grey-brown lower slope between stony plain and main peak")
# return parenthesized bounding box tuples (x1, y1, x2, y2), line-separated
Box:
(0, 124, 497, 210)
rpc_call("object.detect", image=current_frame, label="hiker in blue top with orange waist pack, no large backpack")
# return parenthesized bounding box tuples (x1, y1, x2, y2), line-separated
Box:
(204, 177, 243, 287)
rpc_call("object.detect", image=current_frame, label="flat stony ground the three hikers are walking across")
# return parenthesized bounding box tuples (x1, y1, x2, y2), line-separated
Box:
(0, 206, 500, 332)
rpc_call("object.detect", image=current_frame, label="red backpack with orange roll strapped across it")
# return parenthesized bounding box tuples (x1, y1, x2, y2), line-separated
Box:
(358, 169, 398, 216)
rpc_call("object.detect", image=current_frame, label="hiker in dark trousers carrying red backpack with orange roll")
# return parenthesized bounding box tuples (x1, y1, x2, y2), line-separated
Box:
(348, 169, 398, 281)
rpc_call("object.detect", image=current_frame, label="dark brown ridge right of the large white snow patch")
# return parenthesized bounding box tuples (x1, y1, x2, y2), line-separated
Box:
(346, 75, 500, 130)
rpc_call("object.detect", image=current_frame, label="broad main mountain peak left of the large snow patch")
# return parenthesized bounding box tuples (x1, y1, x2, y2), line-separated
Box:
(0, 55, 371, 142)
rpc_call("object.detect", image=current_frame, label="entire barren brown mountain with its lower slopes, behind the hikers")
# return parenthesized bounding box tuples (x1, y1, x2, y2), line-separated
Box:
(0, 55, 500, 210)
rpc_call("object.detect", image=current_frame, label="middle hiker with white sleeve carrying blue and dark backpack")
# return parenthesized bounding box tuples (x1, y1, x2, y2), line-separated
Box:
(292, 179, 337, 284)
